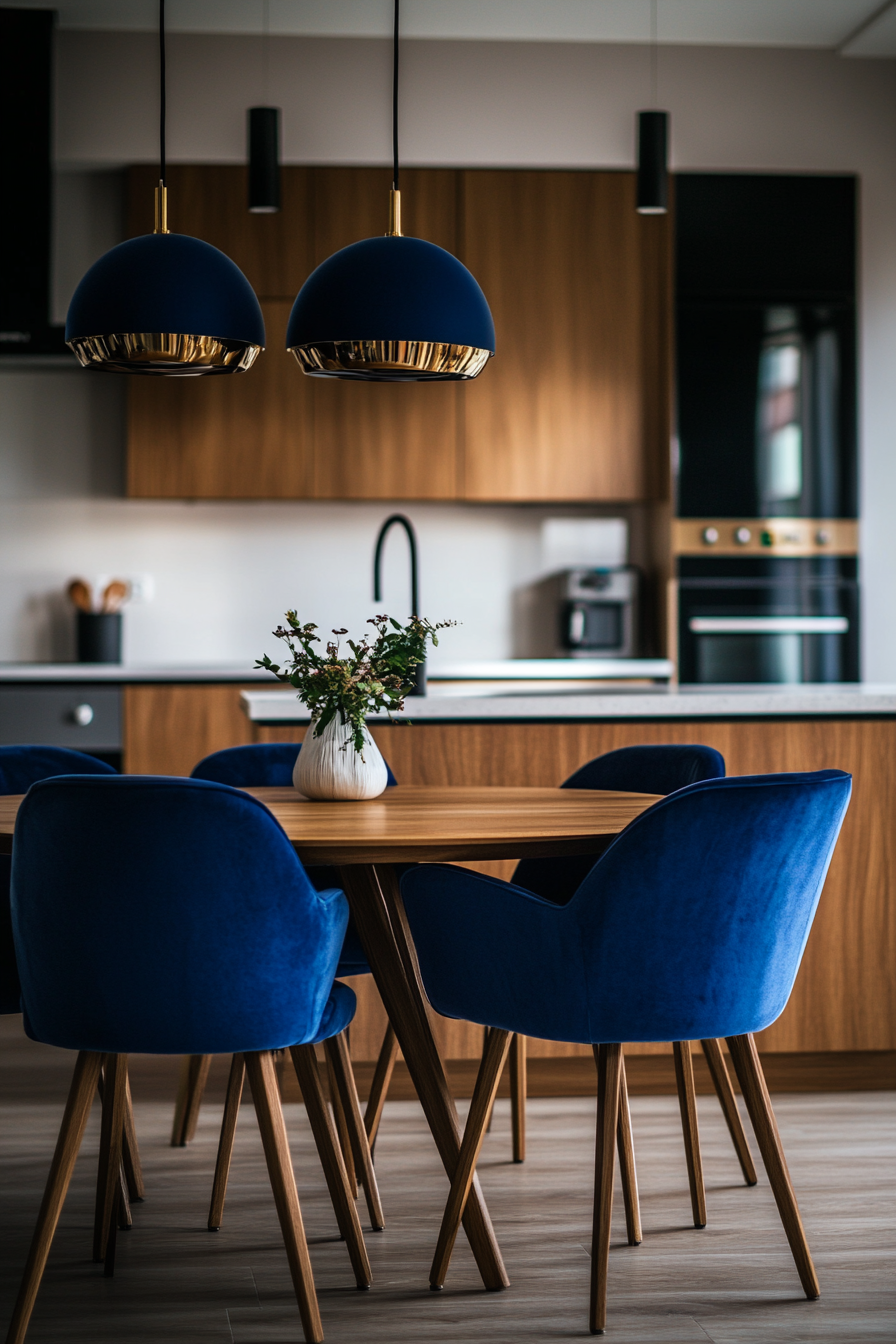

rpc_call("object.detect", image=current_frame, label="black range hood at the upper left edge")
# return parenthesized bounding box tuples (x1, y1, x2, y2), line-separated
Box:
(0, 9, 70, 358)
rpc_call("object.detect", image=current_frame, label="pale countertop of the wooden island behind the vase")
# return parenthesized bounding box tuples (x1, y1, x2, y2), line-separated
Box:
(240, 683, 896, 724)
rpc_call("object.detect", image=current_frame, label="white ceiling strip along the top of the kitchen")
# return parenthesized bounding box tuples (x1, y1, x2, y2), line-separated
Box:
(7, 0, 896, 56)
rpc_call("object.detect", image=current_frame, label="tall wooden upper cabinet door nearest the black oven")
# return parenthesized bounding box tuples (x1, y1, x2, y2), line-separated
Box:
(463, 171, 668, 501)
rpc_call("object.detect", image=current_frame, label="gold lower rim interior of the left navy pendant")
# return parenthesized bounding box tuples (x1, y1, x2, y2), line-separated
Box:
(69, 332, 263, 378)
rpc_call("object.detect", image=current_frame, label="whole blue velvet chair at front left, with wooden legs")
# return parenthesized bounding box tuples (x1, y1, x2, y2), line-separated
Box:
(8, 775, 369, 1344)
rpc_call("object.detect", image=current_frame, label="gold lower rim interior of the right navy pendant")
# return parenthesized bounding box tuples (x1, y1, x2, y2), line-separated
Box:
(292, 340, 492, 382)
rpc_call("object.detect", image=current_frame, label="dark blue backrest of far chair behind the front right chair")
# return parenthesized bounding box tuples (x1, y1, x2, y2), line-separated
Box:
(512, 743, 725, 906)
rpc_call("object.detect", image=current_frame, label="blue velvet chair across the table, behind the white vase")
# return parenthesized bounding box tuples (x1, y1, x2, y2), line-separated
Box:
(182, 742, 398, 1171)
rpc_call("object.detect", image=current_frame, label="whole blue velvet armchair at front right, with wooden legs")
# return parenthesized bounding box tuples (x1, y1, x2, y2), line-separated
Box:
(402, 770, 852, 1333)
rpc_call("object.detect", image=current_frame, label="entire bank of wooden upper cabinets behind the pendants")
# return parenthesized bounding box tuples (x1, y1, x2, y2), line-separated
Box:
(128, 165, 672, 501)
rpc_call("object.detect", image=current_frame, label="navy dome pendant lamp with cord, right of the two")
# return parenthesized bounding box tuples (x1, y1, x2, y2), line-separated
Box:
(286, 0, 494, 383)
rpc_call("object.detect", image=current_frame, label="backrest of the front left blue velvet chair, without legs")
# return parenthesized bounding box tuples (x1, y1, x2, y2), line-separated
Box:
(12, 775, 348, 1055)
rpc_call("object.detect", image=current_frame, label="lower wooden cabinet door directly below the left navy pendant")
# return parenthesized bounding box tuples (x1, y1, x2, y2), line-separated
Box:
(128, 298, 313, 499)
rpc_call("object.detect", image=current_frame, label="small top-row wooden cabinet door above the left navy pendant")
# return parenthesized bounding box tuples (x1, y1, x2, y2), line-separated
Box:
(128, 164, 314, 298)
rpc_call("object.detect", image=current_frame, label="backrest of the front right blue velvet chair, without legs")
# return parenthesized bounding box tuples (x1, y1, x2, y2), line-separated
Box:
(560, 770, 852, 1042)
